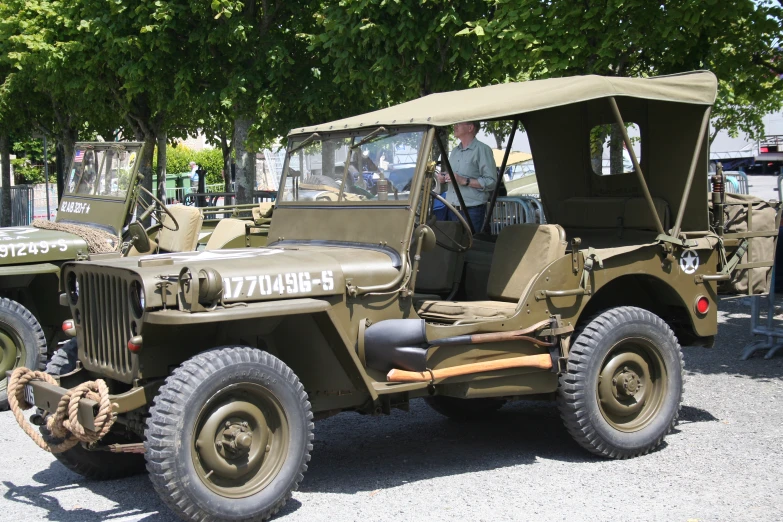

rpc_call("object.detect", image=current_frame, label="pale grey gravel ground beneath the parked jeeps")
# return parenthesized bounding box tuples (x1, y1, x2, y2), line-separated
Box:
(0, 301, 783, 522)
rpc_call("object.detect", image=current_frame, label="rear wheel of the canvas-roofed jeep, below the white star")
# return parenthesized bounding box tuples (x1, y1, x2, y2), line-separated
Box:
(558, 306, 683, 459)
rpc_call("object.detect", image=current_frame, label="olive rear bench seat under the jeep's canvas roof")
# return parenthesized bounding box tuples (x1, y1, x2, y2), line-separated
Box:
(555, 197, 670, 248)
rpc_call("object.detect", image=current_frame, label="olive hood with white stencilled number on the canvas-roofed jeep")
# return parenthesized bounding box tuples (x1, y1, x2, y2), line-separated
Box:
(68, 245, 399, 310)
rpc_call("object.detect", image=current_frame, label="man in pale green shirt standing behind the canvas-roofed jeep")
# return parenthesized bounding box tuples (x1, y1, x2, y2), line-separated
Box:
(438, 121, 498, 233)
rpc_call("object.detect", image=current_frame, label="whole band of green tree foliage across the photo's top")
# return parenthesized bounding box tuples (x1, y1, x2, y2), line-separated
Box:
(0, 0, 783, 213)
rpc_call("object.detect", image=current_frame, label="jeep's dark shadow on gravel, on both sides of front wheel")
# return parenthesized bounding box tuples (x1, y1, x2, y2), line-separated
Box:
(2, 400, 602, 522)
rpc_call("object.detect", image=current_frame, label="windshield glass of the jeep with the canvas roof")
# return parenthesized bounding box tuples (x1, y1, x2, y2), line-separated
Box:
(279, 127, 424, 203)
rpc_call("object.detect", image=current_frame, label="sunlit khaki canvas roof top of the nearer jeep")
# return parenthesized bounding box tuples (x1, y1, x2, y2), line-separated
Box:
(289, 71, 718, 136)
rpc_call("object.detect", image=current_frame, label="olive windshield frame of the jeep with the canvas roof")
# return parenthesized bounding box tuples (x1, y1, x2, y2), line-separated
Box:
(275, 124, 431, 208)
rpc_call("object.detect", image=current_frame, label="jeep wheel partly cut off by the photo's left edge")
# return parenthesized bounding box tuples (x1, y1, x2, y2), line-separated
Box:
(0, 297, 46, 410)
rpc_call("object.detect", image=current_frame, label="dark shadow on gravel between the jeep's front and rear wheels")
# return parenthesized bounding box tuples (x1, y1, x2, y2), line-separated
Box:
(301, 400, 600, 494)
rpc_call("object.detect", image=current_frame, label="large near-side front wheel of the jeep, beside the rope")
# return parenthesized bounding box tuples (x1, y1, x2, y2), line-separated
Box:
(145, 347, 313, 521)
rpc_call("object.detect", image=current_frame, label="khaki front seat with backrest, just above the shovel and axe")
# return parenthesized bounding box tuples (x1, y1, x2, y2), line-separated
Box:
(417, 224, 567, 322)
